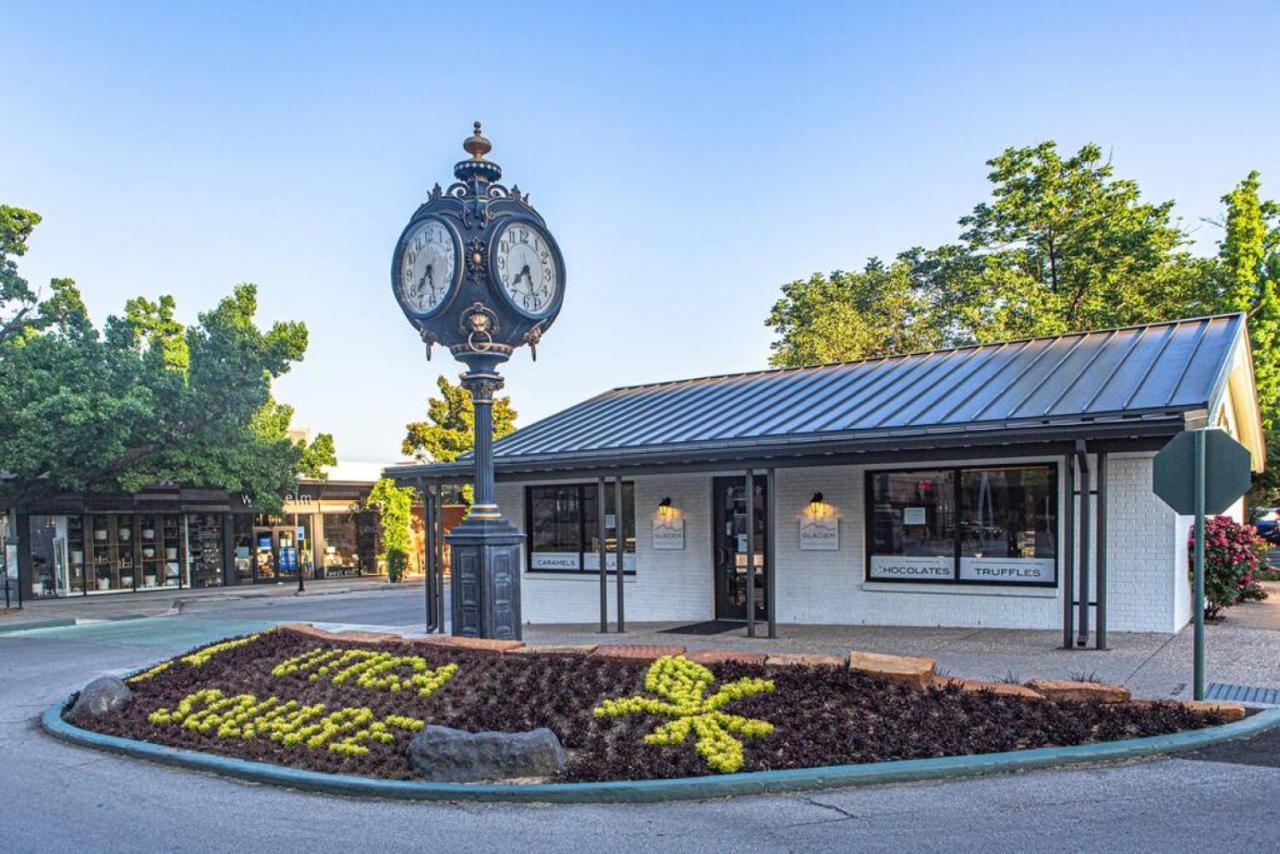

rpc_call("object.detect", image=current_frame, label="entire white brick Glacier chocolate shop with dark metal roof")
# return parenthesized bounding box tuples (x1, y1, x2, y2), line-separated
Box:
(388, 315, 1265, 636)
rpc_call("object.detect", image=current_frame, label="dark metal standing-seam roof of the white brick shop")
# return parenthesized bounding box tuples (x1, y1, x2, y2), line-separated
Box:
(389, 314, 1245, 481)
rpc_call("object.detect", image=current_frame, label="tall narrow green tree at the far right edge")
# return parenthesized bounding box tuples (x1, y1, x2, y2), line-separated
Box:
(1219, 172, 1280, 501)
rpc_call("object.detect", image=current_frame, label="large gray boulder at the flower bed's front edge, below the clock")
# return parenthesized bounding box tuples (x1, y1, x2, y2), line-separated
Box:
(407, 726, 564, 782)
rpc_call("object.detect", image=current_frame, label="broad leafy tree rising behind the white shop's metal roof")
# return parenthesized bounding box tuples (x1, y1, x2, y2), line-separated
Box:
(767, 142, 1216, 366)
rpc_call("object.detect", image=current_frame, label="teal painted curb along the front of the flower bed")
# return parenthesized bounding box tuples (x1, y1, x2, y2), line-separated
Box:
(41, 698, 1280, 804)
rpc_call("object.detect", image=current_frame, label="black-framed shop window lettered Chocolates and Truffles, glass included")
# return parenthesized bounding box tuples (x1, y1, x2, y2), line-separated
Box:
(867, 465, 1057, 586)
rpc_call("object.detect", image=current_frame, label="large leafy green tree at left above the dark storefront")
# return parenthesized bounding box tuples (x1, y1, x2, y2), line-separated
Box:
(0, 207, 333, 511)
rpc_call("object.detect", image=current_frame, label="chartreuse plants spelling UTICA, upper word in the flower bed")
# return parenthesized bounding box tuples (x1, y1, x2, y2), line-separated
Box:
(271, 647, 458, 697)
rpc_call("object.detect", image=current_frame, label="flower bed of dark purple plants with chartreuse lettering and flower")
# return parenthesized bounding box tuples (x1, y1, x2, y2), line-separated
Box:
(72, 629, 1220, 781)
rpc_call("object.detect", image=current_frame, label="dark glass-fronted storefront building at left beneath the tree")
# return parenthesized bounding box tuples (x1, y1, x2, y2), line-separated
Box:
(0, 463, 394, 598)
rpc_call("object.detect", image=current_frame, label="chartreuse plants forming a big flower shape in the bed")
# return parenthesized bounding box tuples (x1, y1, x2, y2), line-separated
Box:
(593, 656, 773, 773)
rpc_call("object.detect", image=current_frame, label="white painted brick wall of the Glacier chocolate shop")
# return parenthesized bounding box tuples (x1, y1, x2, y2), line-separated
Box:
(498, 455, 1190, 632)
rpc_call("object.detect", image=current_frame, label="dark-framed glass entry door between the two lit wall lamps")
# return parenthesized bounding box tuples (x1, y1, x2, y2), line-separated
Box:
(712, 475, 769, 620)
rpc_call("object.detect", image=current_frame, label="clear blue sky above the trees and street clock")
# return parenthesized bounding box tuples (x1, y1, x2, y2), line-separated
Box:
(0, 0, 1280, 461)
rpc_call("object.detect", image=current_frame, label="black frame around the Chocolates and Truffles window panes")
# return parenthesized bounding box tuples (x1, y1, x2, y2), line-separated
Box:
(863, 462, 1064, 590)
